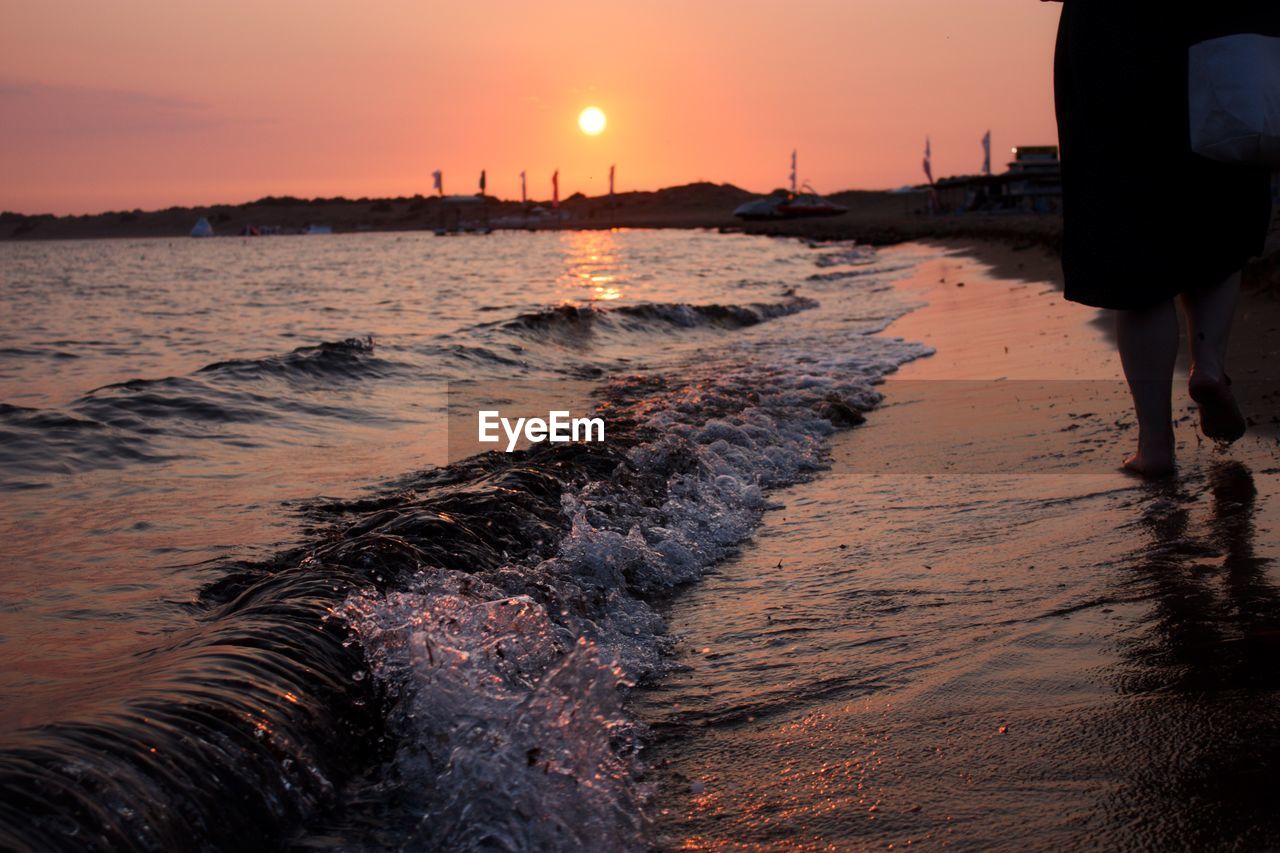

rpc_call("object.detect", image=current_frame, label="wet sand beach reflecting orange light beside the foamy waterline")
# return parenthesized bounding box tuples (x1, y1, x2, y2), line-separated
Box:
(636, 247, 1280, 849)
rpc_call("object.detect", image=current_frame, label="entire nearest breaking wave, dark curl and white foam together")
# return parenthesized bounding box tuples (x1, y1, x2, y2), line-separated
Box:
(0, 327, 920, 850)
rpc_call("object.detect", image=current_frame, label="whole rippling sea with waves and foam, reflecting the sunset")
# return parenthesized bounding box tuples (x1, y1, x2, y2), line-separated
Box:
(0, 229, 942, 850)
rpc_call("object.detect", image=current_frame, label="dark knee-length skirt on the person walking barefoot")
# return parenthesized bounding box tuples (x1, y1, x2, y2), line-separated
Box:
(1053, 0, 1280, 309)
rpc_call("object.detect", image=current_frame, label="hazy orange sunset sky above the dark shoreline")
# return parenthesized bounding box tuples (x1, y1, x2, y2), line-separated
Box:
(0, 0, 1059, 213)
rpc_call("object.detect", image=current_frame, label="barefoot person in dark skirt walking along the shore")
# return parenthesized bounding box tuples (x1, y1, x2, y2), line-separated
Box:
(1053, 0, 1272, 476)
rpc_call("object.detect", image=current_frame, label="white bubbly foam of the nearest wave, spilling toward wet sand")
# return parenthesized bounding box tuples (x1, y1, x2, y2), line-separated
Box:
(325, 342, 924, 850)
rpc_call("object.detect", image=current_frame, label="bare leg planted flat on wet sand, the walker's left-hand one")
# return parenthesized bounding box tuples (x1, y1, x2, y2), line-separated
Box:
(1116, 300, 1178, 476)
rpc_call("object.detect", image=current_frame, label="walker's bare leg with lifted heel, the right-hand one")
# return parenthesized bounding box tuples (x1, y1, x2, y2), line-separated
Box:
(1181, 273, 1245, 442)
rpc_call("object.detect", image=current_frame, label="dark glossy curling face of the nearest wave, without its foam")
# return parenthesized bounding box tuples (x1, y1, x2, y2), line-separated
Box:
(0, 447, 611, 850)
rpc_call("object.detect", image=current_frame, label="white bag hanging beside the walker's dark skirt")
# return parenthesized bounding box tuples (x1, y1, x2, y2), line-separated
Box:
(1189, 33, 1280, 169)
